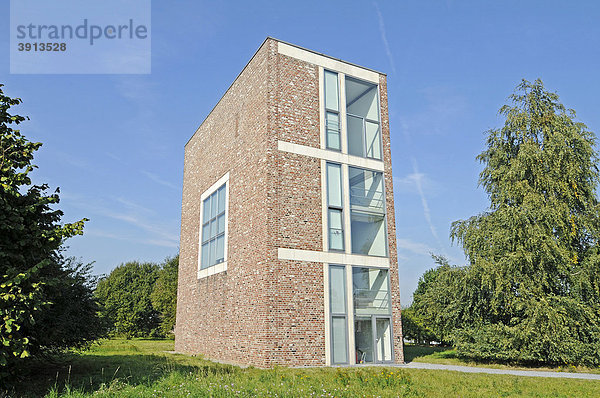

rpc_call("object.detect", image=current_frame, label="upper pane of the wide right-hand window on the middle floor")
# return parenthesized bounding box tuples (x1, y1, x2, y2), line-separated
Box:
(348, 167, 385, 214)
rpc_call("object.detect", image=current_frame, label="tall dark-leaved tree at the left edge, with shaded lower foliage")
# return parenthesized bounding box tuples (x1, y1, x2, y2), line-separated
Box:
(0, 84, 98, 377)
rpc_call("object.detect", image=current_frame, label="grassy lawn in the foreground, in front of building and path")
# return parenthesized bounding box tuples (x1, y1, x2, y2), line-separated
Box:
(5, 340, 600, 398)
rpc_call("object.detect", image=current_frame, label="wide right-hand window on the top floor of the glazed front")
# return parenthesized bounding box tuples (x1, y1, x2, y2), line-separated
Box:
(346, 77, 381, 160)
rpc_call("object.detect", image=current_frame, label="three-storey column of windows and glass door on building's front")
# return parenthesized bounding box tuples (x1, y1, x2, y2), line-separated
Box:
(323, 70, 394, 364)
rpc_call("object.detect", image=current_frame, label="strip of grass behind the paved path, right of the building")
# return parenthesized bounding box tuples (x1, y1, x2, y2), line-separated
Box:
(404, 344, 600, 374)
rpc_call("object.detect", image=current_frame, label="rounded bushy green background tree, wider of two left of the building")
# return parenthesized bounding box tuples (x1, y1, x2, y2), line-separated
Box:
(96, 261, 160, 338)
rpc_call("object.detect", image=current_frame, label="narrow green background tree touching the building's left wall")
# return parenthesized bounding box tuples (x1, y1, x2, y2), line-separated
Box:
(150, 256, 179, 336)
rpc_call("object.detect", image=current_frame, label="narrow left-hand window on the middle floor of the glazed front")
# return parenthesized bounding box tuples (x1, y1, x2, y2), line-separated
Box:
(327, 163, 344, 250)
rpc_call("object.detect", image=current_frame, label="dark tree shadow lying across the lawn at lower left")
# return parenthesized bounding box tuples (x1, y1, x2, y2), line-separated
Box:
(9, 354, 235, 398)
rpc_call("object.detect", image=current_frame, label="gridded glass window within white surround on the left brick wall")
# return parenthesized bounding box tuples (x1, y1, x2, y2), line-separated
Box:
(200, 183, 227, 269)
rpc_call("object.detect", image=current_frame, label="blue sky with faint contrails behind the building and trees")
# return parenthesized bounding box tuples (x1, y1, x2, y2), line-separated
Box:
(0, 0, 600, 304)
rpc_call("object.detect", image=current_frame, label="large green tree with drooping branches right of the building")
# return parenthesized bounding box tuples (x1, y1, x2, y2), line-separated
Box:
(451, 80, 600, 365)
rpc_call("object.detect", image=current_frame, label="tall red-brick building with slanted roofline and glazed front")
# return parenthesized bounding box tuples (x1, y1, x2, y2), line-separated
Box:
(175, 38, 404, 367)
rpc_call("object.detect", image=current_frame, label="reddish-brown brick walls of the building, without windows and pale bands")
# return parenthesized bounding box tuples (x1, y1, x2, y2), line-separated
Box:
(175, 39, 403, 367)
